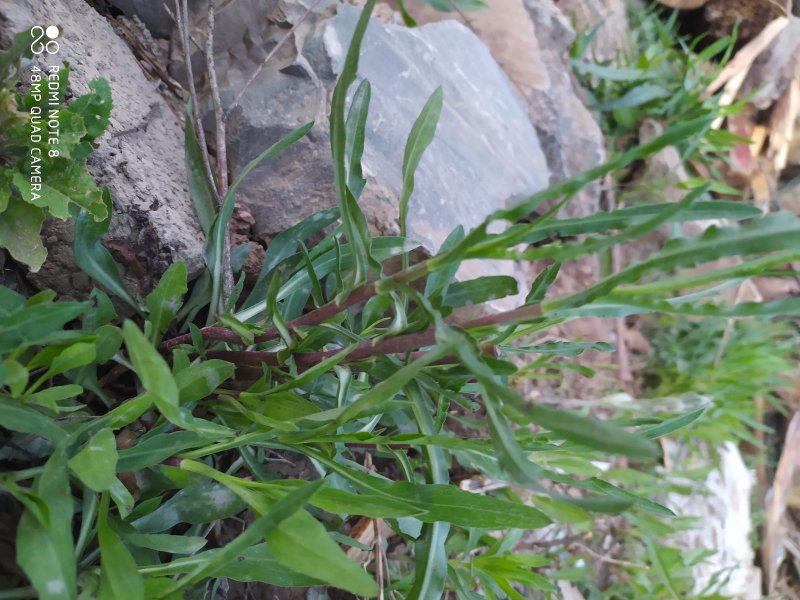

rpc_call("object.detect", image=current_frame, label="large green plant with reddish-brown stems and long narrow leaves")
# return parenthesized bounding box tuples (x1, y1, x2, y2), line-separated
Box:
(0, 0, 800, 600)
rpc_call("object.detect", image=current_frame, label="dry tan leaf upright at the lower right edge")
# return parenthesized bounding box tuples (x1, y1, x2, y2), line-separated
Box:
(761, 412, 800, 594)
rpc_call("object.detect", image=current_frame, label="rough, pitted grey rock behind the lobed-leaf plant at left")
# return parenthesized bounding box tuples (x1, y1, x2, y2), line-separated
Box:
(0, 0, 203, 295)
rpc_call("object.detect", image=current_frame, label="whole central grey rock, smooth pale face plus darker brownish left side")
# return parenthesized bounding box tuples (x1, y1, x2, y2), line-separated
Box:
(215, 5, 549, 251)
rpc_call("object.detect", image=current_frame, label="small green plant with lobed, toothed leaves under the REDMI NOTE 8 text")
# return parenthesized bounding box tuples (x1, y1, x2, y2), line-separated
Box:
(0, 32, 111, 271)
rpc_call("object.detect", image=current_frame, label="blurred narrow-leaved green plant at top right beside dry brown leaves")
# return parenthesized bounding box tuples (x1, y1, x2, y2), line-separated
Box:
(571, 3, 746, 174)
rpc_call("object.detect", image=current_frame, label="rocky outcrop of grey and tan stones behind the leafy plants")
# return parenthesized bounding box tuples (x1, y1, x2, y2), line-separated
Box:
(0, 0, 605, 302)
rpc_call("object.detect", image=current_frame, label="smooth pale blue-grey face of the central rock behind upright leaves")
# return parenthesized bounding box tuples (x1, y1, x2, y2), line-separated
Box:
(324, 6, 549, 255)
